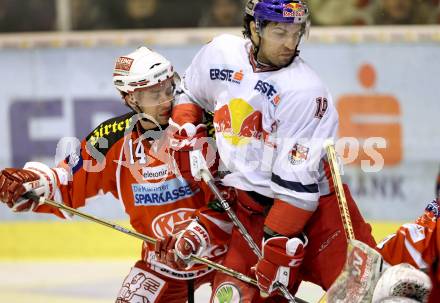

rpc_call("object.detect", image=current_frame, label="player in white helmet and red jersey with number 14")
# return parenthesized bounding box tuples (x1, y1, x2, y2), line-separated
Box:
(0, 47, 231, 303)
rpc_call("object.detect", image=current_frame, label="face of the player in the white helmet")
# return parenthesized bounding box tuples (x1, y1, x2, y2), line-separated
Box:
(133, 79, 174, 128)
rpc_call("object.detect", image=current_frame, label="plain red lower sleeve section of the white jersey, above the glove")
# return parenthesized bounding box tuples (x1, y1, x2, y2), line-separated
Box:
(264, 199, 313, 237)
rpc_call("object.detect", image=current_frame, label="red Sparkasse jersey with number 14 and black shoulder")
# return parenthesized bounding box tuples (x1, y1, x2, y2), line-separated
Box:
(37, 113, 232, 279)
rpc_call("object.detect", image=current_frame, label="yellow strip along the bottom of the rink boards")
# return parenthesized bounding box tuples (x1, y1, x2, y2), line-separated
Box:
(0, 221, 400, 260)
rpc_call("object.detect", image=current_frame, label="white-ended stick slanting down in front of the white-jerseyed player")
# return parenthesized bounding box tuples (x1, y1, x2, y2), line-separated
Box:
(190, 149, 296, 303)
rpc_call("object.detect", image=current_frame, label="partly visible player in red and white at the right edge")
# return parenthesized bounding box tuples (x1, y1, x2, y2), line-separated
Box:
(373, 173, 440, 303)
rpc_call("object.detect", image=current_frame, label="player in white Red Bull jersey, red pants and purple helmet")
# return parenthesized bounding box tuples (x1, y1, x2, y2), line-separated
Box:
(161, 0, 375, 302)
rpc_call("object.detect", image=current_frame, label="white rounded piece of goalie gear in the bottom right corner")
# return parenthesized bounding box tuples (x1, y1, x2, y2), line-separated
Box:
(372, 263, 432, 303)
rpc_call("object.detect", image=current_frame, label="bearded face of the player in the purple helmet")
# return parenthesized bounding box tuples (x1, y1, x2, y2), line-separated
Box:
(257, 22, 301, 67)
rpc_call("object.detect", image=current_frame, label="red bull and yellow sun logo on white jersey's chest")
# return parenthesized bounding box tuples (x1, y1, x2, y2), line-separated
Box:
(214, 99, 263, 146)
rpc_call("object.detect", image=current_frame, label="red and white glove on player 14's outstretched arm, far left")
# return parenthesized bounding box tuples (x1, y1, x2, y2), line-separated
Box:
(0, 162, 57, 212)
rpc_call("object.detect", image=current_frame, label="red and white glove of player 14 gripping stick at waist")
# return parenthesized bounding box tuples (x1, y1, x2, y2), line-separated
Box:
(155, 220, 210, 269)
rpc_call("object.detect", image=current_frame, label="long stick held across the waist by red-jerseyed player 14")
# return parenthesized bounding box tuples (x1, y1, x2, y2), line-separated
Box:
(24, 191, 258, 286)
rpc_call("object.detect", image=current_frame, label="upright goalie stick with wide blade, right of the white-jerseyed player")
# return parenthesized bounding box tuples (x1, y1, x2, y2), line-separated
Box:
(319, 140, 382, 303)
